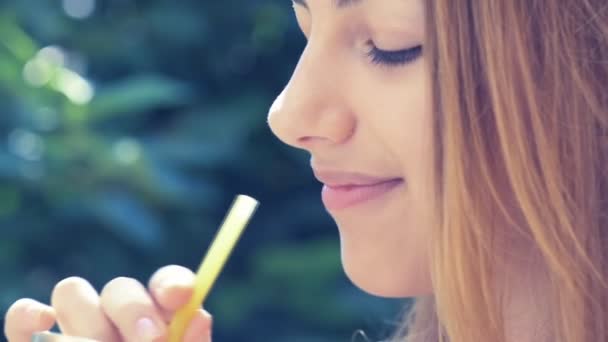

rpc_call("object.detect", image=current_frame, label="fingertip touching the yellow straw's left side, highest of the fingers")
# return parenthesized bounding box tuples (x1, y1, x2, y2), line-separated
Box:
(148, 265, 194, 316)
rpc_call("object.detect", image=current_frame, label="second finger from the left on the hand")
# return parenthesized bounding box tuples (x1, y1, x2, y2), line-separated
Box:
(51, 277, 119, 341)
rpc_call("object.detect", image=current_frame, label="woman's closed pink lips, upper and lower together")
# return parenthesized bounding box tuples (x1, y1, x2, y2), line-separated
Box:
(314, 170, 404, 211)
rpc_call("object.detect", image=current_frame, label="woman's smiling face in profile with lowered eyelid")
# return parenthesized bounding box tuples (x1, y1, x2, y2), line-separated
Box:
(268, 0, 436, 297)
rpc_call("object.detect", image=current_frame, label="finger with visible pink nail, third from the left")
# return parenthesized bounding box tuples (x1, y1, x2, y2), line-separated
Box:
(101, 277, 167, 342)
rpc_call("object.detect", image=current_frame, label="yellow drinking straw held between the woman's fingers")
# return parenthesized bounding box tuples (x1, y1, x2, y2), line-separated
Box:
(169, 195, 258, 342)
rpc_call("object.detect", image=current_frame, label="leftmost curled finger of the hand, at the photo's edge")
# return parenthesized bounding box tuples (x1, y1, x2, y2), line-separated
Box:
(4, 298, 55, 342)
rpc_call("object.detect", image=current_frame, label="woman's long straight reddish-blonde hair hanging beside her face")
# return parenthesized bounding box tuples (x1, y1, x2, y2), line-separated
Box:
(395, 0, 608, 342)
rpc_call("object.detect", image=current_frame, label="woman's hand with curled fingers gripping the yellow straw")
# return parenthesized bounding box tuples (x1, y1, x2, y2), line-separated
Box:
(4, 265, 211, 342)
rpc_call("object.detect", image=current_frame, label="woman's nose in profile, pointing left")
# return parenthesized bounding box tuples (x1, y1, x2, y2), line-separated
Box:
(268, 39, 356, 153)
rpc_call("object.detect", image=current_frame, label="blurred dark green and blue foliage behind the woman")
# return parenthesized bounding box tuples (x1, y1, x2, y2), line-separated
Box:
(0, 0, 403, 342)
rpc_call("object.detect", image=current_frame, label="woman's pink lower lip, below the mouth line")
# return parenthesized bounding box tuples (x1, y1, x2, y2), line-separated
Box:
(321, 179, 403, 211)
